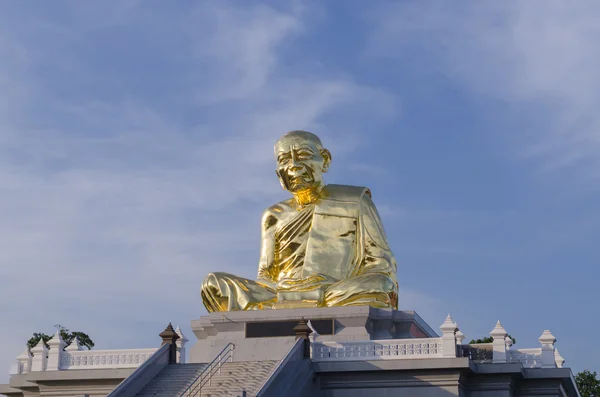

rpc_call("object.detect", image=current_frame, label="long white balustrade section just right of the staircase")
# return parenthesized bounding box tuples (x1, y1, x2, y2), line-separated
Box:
(312, 338, 442, 361)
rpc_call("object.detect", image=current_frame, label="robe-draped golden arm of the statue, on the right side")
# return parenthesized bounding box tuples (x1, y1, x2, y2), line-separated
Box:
(354, 194, 396, 279)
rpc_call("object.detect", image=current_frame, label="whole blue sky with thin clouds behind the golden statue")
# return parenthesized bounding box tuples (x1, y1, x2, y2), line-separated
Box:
(0, 0, 600, 381)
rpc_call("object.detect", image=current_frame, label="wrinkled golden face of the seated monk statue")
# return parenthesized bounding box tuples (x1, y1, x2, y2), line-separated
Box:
(275, 135, 331, 193)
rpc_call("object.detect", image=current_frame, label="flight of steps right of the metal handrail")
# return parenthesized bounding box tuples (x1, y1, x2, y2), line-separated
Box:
(198, 360, 279, 397)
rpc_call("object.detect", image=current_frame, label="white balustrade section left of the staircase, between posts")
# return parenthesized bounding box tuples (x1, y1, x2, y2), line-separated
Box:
(60, 348, 158, 370)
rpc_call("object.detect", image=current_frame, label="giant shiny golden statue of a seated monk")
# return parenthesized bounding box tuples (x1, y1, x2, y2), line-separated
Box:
(201, 131, 398, 312)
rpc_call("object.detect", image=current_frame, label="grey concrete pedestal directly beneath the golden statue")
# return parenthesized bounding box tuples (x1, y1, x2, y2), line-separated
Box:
(190, 306, 438, 363)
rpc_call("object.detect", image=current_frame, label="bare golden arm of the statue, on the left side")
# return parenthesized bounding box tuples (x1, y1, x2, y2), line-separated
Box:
(257, 207, 279, 289)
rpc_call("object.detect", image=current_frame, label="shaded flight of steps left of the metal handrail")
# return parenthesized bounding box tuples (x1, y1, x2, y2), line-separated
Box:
(135, 364, 207, 397)
